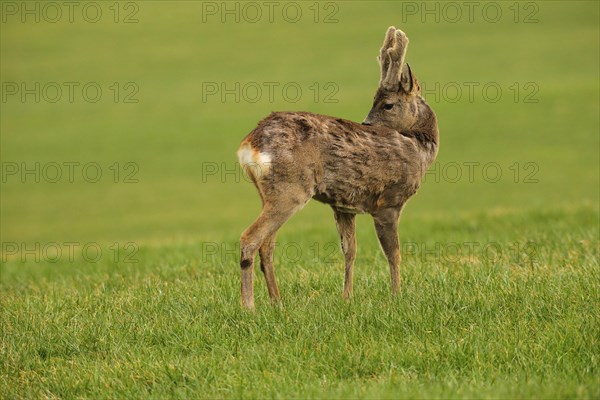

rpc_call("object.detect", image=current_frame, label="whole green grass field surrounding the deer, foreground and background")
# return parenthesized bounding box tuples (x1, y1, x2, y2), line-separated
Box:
(0, 1, 600, 399)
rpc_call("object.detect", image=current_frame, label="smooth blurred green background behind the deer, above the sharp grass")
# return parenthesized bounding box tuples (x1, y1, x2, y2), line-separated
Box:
(0, 1, 599, 243)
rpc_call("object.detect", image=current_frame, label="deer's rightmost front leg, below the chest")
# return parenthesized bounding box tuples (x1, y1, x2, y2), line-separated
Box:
(373, 209, 400, 294)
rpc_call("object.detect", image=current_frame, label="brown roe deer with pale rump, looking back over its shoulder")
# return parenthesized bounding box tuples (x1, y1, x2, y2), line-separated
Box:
(238, 26, 438, 309)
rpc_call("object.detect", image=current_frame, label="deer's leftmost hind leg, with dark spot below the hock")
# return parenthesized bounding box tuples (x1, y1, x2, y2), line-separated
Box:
(240, 197, 310, 309)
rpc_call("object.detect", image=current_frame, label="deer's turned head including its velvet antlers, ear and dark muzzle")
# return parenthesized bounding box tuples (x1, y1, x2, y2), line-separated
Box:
(363, 26, 422, 131)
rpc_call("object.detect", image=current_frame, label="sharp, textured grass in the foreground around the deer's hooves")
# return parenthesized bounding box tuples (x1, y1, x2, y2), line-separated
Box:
(0, 207, 600, 398)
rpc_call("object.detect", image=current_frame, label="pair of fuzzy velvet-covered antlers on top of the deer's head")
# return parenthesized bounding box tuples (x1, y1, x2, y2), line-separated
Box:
(379, 27, 408, 90)
